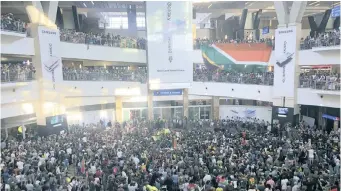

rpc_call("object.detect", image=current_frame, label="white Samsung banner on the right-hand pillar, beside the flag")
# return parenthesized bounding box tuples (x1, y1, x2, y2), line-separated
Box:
(273, 27, 296, 97)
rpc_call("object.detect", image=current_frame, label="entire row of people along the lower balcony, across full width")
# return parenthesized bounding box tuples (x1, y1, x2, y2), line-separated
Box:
(1, 61, 341, 90)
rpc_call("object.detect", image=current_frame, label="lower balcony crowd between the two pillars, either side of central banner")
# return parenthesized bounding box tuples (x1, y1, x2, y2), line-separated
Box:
(63, 67, 273, 85)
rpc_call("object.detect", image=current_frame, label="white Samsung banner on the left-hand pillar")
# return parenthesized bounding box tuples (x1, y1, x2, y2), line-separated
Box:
(38, 26, 63, 90)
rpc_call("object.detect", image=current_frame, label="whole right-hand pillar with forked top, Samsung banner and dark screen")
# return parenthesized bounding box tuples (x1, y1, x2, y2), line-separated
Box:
(272, 1, 307, 127)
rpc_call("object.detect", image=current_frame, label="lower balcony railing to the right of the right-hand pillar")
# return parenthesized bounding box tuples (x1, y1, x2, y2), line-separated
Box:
(299, 79, 340, 91)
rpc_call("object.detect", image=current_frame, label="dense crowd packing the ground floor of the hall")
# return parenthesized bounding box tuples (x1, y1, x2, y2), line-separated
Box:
(0, 117, 340, 191)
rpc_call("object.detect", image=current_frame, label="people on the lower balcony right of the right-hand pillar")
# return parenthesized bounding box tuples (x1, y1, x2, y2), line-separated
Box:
(299, 70, 340, 91)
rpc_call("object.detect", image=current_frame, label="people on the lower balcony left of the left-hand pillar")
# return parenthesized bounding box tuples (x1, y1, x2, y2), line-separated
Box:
(1, 63, 36, 83)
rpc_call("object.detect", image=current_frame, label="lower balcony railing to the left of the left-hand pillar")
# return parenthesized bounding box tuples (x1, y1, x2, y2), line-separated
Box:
(1, 71, 35, 83)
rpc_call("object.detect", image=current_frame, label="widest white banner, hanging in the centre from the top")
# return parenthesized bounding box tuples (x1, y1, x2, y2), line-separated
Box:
(146, 1, 193, 88)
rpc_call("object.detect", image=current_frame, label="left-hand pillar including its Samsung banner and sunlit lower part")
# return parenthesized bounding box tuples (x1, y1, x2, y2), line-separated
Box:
(30, 23, 65, 126)
